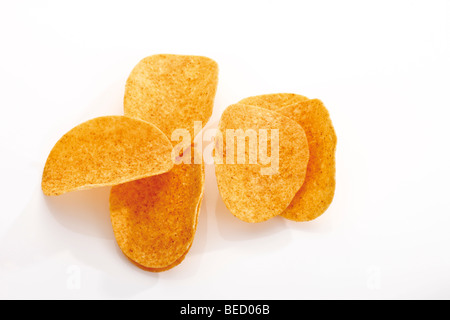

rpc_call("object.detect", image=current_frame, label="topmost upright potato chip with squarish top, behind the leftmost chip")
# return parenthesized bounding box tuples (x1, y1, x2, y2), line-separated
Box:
(124, 54, 218, 141)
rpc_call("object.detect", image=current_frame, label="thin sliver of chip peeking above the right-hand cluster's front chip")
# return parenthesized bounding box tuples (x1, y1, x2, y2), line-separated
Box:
(239, 93, 308, 111)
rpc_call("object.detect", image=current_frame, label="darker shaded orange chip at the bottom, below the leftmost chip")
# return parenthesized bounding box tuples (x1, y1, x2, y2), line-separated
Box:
(110, 150, 204, 272)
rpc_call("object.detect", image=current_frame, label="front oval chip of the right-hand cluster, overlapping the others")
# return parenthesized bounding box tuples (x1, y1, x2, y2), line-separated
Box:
(214, 104, 309, 223)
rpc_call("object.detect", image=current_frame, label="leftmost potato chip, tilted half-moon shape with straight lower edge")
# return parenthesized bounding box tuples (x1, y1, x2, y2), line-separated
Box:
(42, 116, 173, 195)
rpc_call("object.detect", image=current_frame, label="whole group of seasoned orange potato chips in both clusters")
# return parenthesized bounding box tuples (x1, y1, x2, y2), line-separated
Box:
(42, 54, 336, 272)
